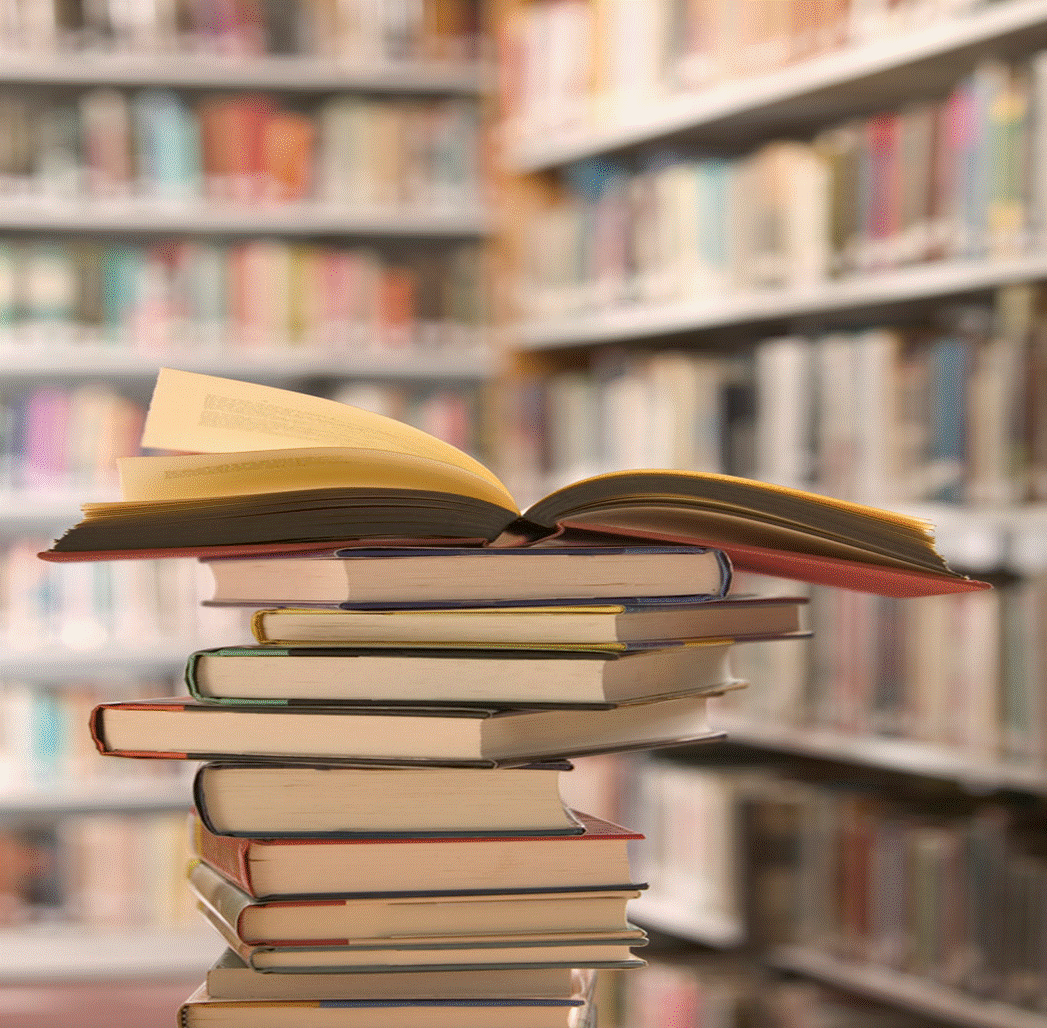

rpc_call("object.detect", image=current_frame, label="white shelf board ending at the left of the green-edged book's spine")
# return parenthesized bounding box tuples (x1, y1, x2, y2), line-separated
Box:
(0, 639, 190, 687)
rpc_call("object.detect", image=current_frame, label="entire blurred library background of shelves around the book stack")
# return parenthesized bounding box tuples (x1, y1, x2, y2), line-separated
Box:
(0, 0, 1047, 1028)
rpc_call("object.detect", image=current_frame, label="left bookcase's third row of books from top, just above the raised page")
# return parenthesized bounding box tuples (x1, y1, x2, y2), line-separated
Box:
(0, 239, 486, 355)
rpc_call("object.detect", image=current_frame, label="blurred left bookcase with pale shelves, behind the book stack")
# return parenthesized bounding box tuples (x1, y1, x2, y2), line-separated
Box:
(0, 0, 489, 985)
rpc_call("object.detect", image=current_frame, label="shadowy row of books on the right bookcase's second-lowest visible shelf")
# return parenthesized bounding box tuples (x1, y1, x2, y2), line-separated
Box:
(607, 754, 1047, 1025)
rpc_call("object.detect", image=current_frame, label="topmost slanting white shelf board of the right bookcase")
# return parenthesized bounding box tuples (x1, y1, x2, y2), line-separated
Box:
(506, 0, 1047, 174)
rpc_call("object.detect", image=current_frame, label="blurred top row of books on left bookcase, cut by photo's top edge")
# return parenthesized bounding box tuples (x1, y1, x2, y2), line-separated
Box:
(0, 0, 480, 62)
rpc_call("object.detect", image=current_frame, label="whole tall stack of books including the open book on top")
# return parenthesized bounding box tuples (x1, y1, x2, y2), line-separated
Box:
(46, 372, 980, 1028)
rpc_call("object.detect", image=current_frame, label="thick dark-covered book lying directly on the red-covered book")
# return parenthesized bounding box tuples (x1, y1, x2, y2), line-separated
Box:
(193, 761, 581, 839)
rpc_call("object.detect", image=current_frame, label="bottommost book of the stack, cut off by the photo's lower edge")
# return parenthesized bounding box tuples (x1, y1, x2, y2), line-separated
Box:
(178, 985, 585, 1028)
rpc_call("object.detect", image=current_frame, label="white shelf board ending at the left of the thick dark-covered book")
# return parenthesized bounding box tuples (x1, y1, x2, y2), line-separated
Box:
(0, 778, 191, 823)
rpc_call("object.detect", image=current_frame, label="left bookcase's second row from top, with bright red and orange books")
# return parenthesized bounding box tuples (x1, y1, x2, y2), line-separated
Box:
(0, 88, 480, 208)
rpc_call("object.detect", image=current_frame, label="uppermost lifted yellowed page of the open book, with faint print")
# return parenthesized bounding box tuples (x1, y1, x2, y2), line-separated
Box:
(139, 367, 516, 510)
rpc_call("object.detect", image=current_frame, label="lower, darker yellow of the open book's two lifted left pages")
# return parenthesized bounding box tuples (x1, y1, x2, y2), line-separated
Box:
(117, 446, 515, 511)
